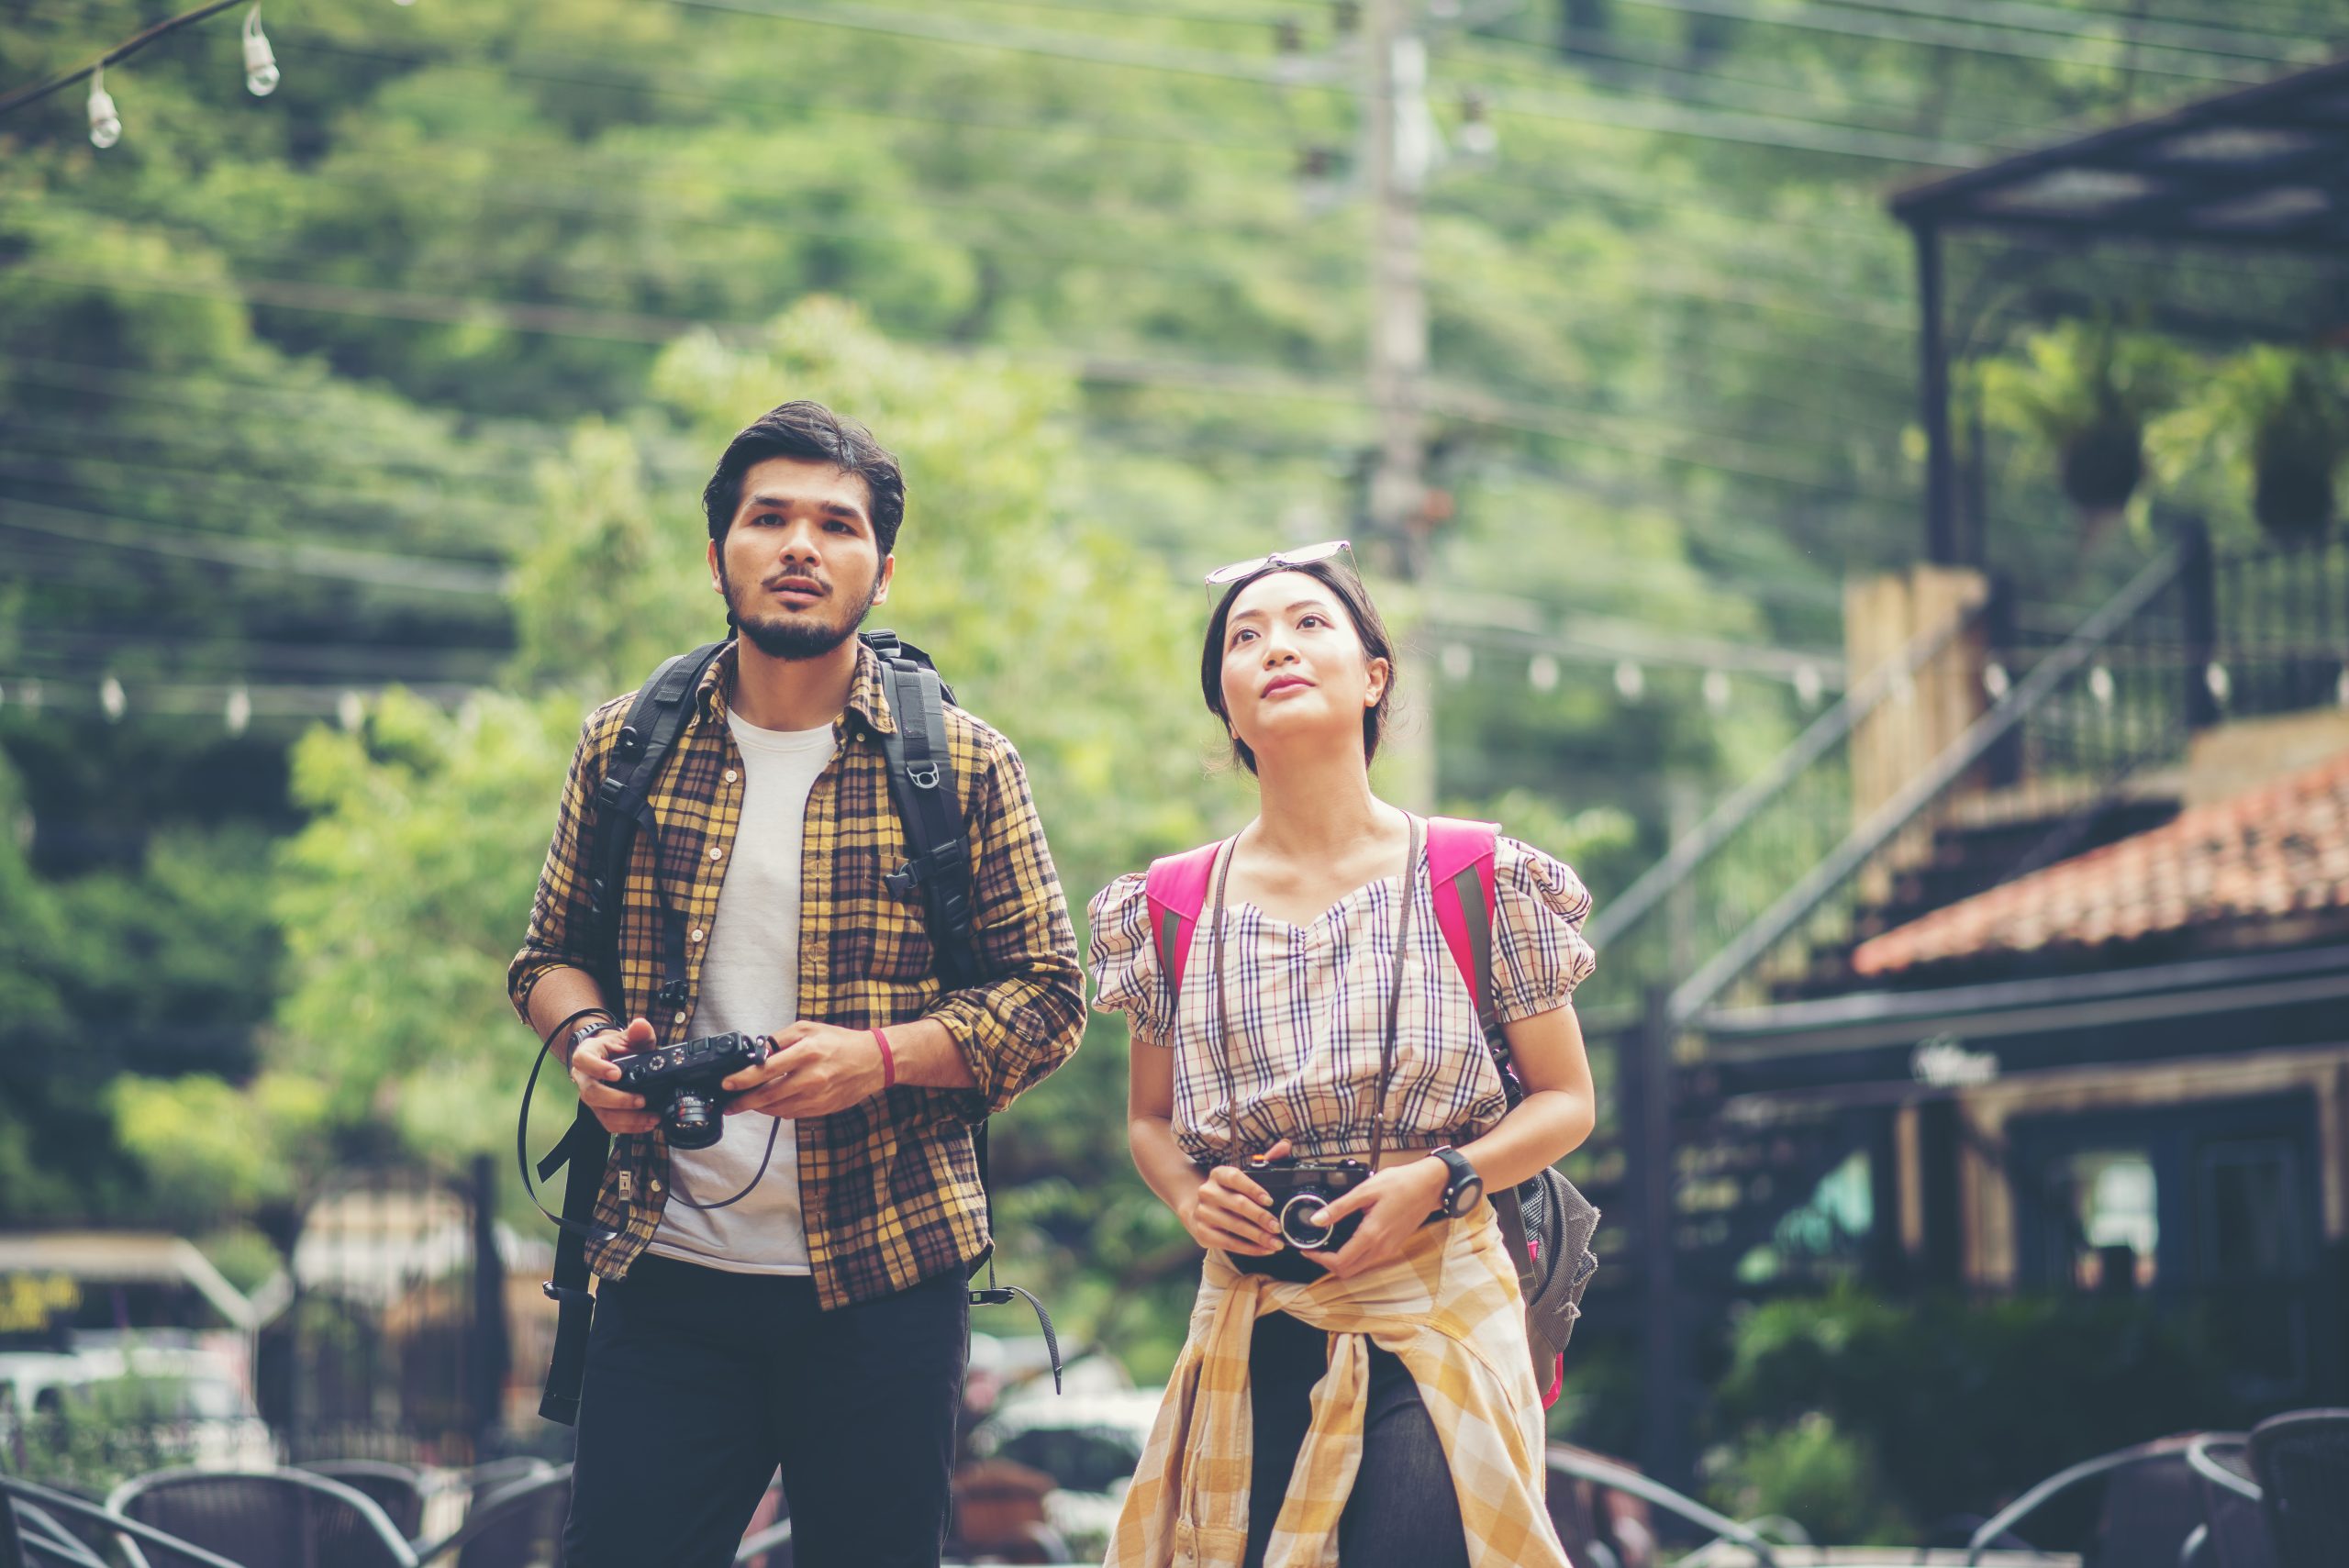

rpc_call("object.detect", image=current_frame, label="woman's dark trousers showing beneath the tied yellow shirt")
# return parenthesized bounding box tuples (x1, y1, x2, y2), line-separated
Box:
(1245, 1312, 1468, 1568)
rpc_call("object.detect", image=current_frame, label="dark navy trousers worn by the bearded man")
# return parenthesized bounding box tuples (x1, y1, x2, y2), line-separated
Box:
(563, 1256, 970, 1568)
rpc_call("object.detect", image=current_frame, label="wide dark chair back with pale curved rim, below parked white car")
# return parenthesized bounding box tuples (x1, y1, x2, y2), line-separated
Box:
(106, 1470, 416, 1568)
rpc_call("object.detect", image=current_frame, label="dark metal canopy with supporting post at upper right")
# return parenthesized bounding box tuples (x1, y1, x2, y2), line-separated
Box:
(1891, 59, 2349, 566)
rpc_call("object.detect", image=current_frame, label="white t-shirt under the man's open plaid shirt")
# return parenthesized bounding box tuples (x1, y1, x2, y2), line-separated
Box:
(651, 714, 834, 1274)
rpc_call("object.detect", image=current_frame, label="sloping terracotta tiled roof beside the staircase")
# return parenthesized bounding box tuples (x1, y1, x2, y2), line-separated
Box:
(1851, 751, 2349, 976)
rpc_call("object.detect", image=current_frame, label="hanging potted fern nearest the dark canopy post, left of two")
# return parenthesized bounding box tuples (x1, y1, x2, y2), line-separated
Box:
(1980, 319, 2180, 521)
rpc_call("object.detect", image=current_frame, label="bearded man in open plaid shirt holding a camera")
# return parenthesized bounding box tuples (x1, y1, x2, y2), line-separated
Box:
(507, 401, 1083, 1568)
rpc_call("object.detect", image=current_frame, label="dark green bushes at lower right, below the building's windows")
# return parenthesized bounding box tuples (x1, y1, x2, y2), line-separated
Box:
(1712, 1286, 2243, 1542)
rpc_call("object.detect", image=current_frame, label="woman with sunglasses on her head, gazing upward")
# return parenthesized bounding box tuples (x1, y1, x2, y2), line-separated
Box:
(1092, 545, 1595, 1568)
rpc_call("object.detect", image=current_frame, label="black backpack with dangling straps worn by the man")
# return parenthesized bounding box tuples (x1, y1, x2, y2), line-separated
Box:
(538, 631, 1060, 1425)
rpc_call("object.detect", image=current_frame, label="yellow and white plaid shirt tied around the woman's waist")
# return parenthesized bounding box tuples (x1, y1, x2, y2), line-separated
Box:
(1107, 1207, 1569, 1568)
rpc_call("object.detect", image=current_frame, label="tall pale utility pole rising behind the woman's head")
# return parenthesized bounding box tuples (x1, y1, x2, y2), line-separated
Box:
(1363, 0, 1438, 812)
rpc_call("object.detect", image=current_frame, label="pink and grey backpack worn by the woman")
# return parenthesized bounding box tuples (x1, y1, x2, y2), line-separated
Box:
(1144, 817, 1599, 1408)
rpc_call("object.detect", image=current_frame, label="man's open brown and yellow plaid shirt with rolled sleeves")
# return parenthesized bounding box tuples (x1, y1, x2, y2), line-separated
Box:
(507, 646, 1083, 1310)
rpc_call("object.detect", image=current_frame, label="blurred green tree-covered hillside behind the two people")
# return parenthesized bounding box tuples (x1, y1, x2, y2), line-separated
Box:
(0, 0, 2337, 1380)
